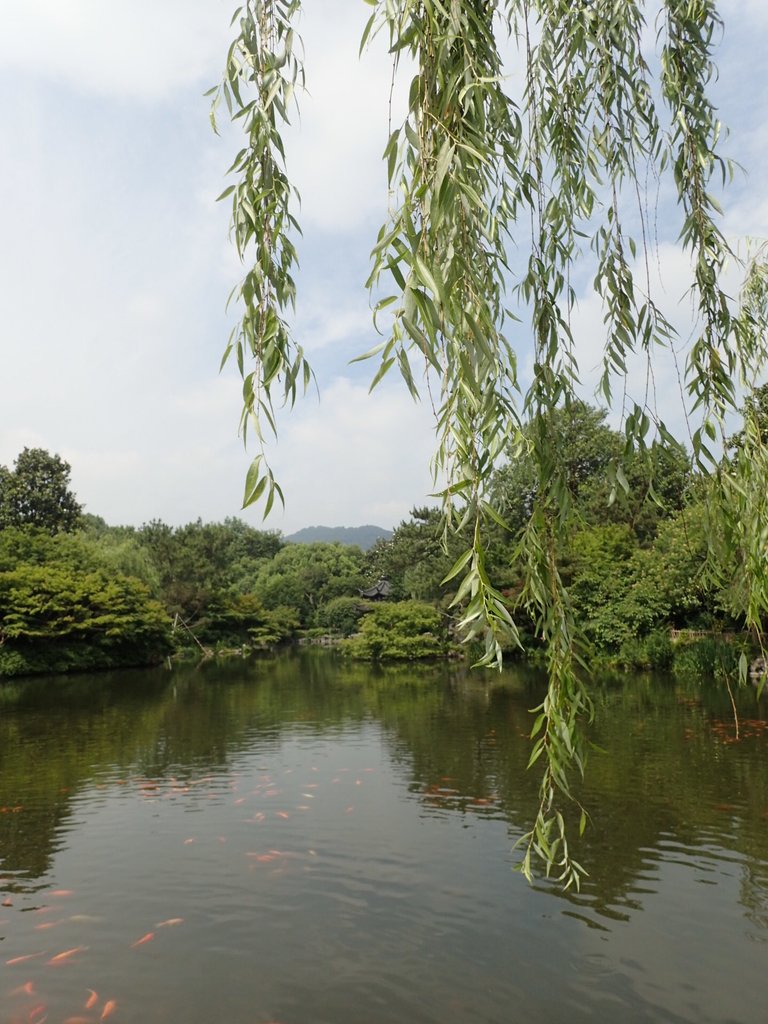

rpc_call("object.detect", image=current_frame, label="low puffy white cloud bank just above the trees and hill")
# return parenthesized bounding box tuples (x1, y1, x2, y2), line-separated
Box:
(52, 378, 433, 534)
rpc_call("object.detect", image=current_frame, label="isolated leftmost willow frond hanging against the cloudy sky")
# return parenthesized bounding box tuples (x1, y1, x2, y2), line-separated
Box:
(210, 0, 311, 517)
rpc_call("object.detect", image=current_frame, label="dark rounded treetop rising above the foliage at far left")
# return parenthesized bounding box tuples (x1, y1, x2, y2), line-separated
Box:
(0, 447, 82, 534)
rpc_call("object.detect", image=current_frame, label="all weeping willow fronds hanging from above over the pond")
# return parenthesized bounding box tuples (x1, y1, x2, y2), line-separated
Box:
(212, 0, 768, 884)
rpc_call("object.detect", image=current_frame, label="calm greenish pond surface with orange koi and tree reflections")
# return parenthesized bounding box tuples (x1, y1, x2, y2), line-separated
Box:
(0, 651, 768, 1024)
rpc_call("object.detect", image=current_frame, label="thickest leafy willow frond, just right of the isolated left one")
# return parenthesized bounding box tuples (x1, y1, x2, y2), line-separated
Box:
(369, 3, 522, 665)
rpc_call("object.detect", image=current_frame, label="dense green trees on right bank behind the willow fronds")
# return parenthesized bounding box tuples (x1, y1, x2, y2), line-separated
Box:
(367, 401, 754, 673)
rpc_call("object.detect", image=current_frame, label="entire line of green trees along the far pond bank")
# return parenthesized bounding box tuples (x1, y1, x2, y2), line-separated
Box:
(0, 385, 768, 676)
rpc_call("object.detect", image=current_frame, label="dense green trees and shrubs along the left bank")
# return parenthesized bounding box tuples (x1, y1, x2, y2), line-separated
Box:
(0, 460, 397, 676)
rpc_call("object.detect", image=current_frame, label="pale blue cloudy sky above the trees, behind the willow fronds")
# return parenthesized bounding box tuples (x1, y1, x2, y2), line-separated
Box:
(0, 0, 768, 534)
